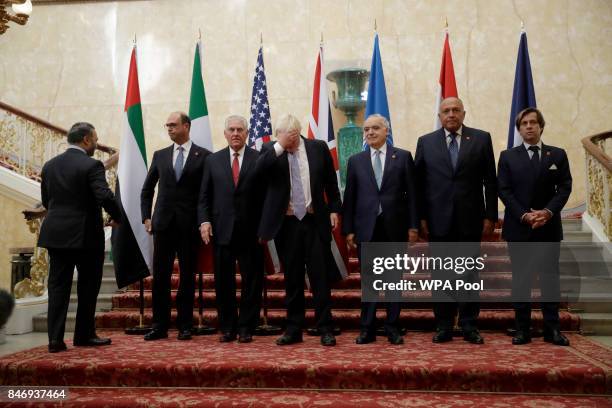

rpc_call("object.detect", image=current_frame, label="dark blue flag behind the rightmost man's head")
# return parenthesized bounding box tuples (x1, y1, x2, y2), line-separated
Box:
(508, 30, 537, 149)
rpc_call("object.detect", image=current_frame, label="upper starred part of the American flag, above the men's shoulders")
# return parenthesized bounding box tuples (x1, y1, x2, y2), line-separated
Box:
(248, 47, 272, 150)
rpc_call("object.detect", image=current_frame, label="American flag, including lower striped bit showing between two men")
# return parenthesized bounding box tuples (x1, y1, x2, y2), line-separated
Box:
(247, 46, 281, 274)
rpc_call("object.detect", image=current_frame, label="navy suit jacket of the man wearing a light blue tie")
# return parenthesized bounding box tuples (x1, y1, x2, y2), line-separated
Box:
(342, 146, 419, 242)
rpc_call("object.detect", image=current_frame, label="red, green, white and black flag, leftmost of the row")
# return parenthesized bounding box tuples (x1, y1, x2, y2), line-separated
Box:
(111, 45, 153, 288)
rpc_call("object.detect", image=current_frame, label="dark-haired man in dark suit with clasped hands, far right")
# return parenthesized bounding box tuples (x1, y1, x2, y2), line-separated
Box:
(498, 108, 572, 346)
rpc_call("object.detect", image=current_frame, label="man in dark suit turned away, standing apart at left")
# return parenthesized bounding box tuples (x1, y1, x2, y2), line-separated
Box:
(38, 122, 121, 353)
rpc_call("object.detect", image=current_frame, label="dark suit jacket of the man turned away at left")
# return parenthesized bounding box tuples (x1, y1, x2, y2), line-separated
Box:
(38, 148, 121, 250)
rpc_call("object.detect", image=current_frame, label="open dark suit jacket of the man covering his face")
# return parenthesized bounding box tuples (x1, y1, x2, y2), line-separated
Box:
(257, 138, 341, 242)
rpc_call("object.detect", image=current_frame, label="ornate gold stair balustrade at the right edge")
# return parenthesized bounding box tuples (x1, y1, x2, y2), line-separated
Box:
(582, 131, 612, 241)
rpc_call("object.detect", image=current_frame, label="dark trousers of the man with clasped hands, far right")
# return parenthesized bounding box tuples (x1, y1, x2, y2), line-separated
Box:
(508, 242, 561, 333)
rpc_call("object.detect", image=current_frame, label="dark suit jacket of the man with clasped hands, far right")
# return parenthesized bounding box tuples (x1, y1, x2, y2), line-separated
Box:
(498, 144, 572, 242)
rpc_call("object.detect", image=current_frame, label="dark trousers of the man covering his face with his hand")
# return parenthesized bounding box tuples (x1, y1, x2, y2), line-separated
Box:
(274, 214, 332, 335)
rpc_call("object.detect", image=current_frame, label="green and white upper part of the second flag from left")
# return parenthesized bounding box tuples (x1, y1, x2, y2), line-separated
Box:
(189, 41, 213, 152)
